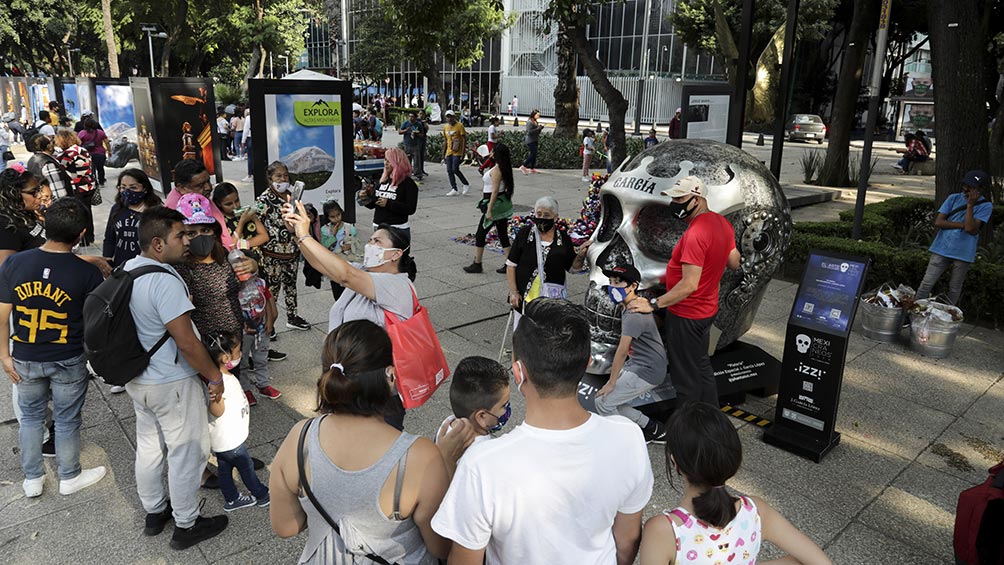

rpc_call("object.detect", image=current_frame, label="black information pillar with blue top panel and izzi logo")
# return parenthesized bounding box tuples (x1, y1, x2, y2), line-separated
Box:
(763, 250, 868, 463)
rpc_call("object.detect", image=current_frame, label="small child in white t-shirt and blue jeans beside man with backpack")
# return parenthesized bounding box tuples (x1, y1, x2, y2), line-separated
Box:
(203, 332, 270, 512)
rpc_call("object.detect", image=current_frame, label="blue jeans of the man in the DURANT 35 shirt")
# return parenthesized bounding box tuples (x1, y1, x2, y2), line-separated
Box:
(14, 354, 88, 481)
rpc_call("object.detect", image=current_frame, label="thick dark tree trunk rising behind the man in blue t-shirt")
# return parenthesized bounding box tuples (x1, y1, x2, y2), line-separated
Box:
(928, 0, 990, 206)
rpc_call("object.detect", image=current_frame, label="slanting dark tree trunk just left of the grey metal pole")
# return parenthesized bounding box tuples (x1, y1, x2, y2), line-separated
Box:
(819, 0, 875, 187)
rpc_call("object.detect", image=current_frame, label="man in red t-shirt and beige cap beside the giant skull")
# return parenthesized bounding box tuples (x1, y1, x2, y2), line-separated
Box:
(629, 177, 740, 407)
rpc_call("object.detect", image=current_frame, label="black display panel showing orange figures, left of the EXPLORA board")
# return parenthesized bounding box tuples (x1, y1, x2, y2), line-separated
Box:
(130, 77, 223, 189)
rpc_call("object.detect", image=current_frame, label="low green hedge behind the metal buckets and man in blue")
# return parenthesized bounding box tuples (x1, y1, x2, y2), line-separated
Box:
(781, 197, 1004, 325)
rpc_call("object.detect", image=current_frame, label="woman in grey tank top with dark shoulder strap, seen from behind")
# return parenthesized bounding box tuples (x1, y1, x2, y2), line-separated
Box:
(269, 320, 473, 565)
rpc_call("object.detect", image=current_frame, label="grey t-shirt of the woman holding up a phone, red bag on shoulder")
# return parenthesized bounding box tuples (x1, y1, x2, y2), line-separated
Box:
(327, 273, 415, 332)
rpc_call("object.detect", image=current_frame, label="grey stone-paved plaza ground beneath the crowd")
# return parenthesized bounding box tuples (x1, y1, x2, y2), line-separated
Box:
(0, 125, 1004, 564)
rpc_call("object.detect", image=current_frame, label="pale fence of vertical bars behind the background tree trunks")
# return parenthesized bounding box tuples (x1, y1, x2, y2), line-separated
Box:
(502, 76, 702, 124)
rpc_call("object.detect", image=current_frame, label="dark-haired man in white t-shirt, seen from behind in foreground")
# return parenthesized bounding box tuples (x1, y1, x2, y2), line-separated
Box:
(432, 298, 653, 565)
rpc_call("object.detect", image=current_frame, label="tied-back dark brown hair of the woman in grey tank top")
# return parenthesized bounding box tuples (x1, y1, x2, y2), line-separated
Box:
(317, 320, 394, 416)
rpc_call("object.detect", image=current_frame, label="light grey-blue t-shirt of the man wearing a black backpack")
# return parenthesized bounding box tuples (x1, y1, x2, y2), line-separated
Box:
(124, 256, 198, 384)
